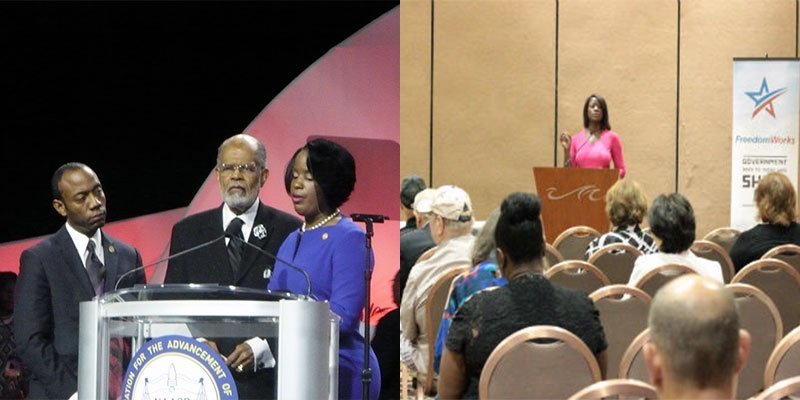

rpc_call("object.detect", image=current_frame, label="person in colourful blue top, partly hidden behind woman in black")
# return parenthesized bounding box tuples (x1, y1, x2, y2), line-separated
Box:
(433, 208, 506, 373)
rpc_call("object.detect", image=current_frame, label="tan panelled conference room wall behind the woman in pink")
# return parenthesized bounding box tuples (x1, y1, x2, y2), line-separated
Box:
(400, 0, 798, 240)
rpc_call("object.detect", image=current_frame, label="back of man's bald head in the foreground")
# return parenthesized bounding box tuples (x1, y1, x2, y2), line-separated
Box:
(648, 274, 749, 389)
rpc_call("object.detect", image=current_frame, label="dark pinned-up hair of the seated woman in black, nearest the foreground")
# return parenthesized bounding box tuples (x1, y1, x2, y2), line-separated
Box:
(494, 192, 544, 263)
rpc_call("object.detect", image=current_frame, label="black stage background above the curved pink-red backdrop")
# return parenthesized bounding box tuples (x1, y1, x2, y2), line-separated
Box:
(0, 1, 399, 242)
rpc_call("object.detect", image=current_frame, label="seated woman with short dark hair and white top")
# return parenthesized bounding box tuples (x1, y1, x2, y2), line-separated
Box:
(628, 193, 723, 286)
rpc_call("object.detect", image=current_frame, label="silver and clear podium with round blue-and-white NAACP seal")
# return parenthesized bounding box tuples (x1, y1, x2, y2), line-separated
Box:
(78, 284, 339, 400)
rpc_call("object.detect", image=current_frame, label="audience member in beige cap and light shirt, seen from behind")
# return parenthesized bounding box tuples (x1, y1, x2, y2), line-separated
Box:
(400, 186, 475, 375)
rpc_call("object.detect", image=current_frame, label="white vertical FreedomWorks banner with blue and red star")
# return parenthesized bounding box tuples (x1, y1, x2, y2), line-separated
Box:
(731, 59, 800, 230)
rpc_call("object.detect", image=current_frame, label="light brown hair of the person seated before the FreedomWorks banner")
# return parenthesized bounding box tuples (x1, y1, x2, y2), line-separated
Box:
(753, 172, 797, 226)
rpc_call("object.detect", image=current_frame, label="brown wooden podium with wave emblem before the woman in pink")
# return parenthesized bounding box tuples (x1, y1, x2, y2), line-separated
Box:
(533, 167, 619, 243)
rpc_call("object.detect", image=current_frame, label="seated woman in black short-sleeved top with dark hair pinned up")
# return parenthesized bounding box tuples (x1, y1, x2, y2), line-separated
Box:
(439, 193, 608, 399)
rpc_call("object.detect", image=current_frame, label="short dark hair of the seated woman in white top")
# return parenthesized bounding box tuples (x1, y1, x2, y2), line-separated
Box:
(647, 193, 695, 254)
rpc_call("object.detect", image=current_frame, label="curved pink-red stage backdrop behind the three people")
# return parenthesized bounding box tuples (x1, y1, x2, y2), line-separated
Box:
(0, 7, 400, 323)
